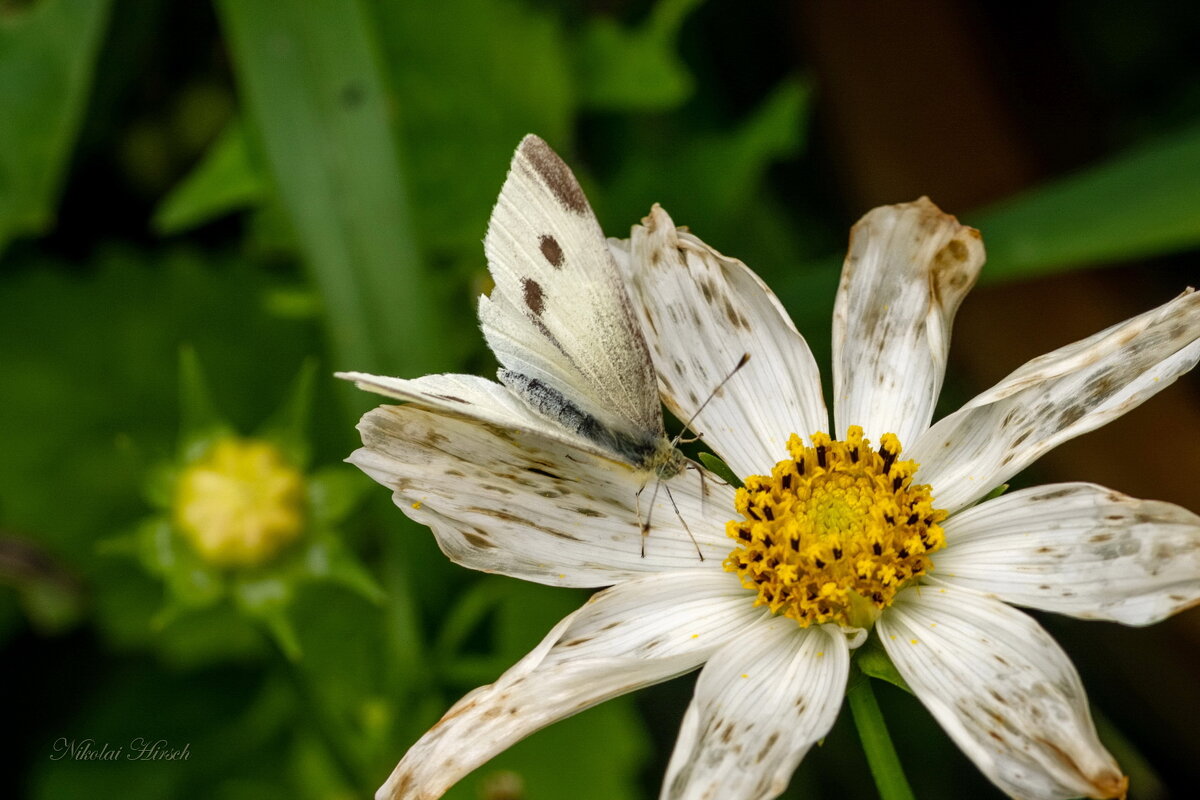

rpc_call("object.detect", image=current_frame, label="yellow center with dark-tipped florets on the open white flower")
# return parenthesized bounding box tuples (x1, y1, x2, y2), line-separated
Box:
(725, 426, 947, 627)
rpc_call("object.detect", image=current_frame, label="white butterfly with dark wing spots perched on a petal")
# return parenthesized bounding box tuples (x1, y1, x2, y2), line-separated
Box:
(338, 134, 703, 558)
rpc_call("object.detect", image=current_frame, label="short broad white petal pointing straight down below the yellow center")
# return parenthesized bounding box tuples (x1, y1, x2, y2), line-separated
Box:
(661, 616, 850, 800)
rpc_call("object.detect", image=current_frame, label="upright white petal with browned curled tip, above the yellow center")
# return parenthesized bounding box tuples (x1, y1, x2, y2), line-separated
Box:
(833, 197, 984, 446)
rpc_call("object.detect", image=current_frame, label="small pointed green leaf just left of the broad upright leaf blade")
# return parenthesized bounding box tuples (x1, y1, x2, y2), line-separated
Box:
(154, 119, 270, 234)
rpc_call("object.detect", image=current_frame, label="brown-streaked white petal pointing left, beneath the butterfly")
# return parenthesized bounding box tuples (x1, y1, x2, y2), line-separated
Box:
(348, 405, 733, 587)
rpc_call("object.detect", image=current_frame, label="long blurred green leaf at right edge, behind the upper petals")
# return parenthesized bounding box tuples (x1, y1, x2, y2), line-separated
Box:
(965, 118, 1200, 281)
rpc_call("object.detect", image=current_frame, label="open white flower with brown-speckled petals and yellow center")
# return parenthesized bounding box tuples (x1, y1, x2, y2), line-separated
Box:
(352, 199, 1200, 800)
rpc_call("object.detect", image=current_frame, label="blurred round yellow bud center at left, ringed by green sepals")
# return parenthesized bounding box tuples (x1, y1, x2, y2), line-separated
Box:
(175, 438, 304, 566)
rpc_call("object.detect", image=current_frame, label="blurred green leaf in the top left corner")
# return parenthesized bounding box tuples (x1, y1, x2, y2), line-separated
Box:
(0, 0, 112, 253)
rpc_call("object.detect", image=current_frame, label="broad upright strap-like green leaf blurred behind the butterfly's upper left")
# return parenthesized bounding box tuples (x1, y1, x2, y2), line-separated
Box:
(217, 0, 437, 374)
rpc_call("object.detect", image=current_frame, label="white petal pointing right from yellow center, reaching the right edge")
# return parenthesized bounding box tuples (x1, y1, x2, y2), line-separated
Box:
(929, 483, 1200, 625)
